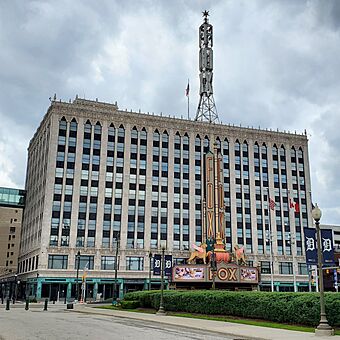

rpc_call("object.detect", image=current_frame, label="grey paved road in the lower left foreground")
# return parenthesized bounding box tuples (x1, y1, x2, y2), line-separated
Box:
(0, 305, 231, 340)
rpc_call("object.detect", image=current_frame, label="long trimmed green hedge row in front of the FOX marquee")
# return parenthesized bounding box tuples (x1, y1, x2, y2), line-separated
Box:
(125, 290, 340, 327)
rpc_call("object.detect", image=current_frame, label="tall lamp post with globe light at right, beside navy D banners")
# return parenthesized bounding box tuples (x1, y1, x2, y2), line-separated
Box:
(312, 204, 334, 336)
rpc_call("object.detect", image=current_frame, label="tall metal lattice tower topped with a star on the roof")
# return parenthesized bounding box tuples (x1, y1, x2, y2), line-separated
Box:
(195, 10, 219, 123)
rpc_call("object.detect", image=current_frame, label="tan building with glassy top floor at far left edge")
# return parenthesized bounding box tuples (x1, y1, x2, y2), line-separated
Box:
(0, 187, 25, 296)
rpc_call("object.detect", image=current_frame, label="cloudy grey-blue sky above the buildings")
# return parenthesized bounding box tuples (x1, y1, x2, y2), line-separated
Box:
(0, 0, 340, 224)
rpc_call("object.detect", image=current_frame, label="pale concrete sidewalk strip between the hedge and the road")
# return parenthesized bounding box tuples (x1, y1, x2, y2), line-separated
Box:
(69, 304, 340, 340)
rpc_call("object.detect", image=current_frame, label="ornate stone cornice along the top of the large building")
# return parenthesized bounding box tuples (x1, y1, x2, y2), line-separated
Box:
(42, 99, 308, 146)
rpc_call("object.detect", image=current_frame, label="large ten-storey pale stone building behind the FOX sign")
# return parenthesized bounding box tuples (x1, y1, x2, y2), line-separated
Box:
(18, 98, 312, 298)
